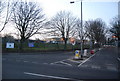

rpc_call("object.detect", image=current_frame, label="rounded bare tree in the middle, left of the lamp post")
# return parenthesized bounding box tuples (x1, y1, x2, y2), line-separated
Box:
(48, 11, 76, 49)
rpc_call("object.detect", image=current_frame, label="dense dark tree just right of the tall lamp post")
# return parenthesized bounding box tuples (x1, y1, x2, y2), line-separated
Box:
(85, 19, 106, 47)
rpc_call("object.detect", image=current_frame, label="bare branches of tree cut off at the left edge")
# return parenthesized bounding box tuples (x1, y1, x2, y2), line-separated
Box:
(0, 1, 12, 32)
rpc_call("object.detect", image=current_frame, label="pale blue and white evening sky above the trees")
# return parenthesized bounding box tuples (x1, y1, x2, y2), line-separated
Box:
(0, 0, 119, 38)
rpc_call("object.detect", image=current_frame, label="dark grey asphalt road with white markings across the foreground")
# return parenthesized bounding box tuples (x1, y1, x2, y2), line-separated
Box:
(2, 47, 119, 81)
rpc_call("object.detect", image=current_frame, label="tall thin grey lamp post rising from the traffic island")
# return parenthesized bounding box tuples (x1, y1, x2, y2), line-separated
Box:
(70, 0, 83, 56)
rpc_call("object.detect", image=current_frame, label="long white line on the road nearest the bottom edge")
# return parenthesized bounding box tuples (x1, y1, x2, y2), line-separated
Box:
(24, 72, 73, 80)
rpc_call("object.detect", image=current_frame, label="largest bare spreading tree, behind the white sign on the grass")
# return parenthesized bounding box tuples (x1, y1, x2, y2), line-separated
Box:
(13, 2, 45, 50)
